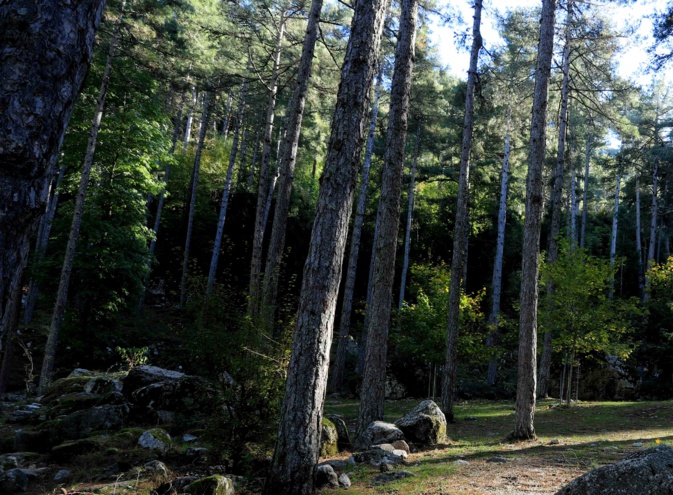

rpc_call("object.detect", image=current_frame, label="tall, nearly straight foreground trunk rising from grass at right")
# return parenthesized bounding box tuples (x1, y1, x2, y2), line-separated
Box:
(512, 0, 556, 439)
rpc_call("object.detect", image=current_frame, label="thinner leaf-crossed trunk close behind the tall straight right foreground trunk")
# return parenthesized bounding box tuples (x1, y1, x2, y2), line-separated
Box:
(537, 1, 573, 404)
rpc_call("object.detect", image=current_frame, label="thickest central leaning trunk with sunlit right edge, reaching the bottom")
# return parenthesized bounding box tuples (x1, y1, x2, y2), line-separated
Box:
(263, 0, 387, 488)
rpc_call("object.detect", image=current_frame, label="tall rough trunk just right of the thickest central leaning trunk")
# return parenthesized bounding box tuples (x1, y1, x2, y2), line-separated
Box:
(358, 0, 418, 431)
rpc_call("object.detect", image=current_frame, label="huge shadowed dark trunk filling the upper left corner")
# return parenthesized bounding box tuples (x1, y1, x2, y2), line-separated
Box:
(0, 0, 105, 336)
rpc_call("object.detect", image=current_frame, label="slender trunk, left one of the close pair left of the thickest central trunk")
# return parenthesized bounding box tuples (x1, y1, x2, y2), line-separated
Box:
(248, 19, 286, 319)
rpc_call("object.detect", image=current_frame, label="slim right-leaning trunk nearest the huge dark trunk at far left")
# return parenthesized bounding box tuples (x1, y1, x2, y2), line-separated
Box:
(38, 0, 126, 395)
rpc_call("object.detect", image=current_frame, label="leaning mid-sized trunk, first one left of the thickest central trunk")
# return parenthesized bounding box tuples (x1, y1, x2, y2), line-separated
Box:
(262, 0, 322, 328)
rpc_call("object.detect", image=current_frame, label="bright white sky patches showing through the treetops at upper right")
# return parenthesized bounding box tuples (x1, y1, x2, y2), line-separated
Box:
(431, 0, 673, 85)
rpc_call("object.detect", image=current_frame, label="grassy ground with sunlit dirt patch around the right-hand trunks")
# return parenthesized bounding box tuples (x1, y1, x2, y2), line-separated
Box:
(325, 399, 673, 495)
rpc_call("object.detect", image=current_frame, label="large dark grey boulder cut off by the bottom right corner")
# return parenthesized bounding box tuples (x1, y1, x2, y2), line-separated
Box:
(556, 445, 673, 495)
